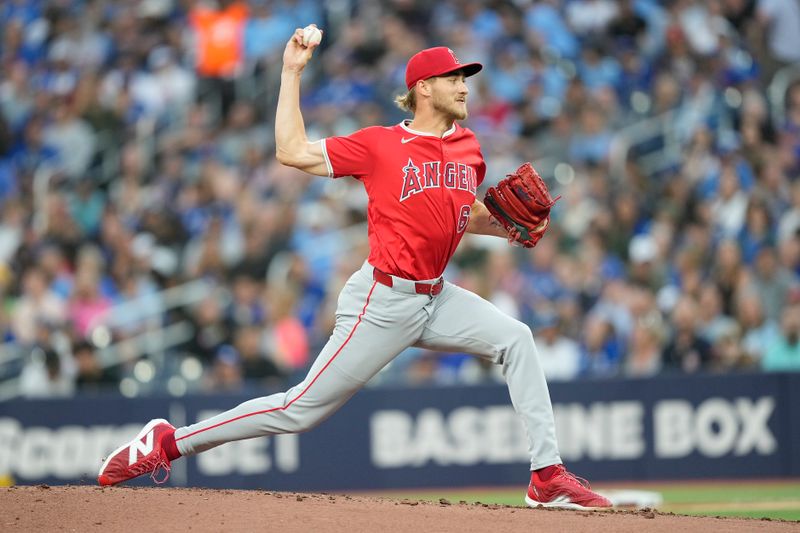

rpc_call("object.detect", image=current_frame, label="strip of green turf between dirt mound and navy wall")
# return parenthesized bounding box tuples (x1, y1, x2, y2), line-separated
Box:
(378, 481, 800, 521)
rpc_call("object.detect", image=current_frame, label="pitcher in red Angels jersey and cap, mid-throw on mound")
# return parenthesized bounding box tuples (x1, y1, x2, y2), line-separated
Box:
(98, 28, 611, 509)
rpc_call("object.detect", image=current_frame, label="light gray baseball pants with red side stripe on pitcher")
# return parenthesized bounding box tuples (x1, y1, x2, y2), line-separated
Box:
(175, 263, 561, 470)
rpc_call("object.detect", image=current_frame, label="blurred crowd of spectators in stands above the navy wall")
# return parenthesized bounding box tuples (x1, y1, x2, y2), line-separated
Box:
(0, 0, 800, 396)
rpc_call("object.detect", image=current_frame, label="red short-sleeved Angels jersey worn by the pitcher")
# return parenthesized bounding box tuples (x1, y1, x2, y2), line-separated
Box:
(322, 122, 486, 280)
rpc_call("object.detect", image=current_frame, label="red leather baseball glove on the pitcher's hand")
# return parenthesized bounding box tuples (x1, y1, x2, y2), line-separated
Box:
(483, 163, 561, 248)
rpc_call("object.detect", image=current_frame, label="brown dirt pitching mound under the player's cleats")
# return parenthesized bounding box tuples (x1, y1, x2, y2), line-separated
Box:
(0, 485, 799, 533)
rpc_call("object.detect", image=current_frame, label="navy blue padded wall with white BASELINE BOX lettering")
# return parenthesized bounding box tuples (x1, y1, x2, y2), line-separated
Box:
(0, 374, 800, 490)
